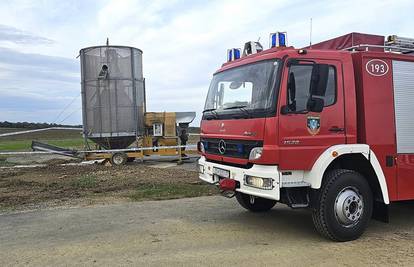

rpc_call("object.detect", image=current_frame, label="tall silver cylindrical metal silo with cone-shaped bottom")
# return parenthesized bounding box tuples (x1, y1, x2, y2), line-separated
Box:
(80, 45, 145, 149)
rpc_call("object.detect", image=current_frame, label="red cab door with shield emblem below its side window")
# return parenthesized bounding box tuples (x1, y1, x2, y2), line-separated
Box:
(279, 59, 346, 170)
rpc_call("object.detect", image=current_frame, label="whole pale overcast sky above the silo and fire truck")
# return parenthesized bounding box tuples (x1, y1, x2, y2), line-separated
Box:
(0, 0, 414, 124)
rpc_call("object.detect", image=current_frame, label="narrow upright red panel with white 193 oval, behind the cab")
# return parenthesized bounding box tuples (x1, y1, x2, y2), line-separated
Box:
(353, 52, 398, 200)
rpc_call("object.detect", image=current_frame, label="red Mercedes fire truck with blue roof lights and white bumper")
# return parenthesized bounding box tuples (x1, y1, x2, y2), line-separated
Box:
(198, 32, 414, 241)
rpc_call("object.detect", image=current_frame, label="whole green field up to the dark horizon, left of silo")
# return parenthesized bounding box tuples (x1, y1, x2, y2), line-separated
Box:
(0, 128, 83, 151)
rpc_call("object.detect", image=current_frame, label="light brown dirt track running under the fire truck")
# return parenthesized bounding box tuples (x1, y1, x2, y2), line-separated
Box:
(0, 196, 414, 266)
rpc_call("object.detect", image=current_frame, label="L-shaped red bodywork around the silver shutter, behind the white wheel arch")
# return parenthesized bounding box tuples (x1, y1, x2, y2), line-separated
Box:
(352, 52, 414, 201)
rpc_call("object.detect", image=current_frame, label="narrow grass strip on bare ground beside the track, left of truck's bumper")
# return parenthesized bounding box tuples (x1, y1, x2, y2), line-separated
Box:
(129, 184, 218, 200)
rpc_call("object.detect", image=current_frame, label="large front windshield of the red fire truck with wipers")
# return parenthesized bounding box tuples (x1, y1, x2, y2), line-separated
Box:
(204, 60, 279, 119)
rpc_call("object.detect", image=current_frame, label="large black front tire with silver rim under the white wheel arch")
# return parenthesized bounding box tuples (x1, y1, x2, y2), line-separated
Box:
(312, 169, 373, 242)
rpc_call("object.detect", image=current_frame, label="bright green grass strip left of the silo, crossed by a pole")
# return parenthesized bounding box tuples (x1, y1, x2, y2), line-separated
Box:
(0, 138, 84, 151)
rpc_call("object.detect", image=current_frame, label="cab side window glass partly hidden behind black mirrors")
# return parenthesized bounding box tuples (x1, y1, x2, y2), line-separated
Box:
(287, 64, 336, 112)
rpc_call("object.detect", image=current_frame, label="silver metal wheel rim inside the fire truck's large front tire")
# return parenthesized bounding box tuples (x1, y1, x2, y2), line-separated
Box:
(334, 187, 364, 227)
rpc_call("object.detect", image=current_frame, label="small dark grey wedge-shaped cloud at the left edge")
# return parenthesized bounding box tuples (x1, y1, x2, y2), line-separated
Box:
(0, 24, 54, 45)
